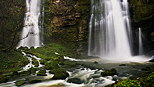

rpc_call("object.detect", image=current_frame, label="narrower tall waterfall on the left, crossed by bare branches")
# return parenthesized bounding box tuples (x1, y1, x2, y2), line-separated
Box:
(17, 0, 41, 48)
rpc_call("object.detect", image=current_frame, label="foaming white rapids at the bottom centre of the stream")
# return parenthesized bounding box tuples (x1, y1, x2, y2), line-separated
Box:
(23, 68, 115, 87)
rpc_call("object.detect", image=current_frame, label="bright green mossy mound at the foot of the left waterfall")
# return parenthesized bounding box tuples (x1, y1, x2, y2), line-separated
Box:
(24, 43, 73, 58)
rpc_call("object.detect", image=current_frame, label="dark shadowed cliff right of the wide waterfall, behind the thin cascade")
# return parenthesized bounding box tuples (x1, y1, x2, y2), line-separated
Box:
(129, 0, 154, 53)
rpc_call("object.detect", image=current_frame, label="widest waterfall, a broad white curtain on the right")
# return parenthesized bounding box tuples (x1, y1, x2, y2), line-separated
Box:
(88, 0, 131, 58)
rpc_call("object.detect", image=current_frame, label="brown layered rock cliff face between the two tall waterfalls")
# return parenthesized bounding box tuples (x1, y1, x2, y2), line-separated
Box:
(44, 0, 90, 54)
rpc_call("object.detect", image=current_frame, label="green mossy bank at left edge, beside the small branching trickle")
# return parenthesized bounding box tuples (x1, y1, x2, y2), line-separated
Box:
(0, 51, 29, 73)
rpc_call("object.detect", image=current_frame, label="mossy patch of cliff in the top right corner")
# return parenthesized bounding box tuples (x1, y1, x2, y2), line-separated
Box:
(130, 0, 154, 22)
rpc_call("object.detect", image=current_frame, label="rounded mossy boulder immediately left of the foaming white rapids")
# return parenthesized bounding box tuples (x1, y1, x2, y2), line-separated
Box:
(50, 68, 69, 79)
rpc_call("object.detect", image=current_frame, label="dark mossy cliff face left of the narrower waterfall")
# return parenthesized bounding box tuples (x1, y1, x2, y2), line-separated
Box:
(0, 0, 25, 50)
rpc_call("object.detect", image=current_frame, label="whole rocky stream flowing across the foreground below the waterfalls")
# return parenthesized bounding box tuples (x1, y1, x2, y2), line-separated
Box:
(0, 52, 154, 87)
